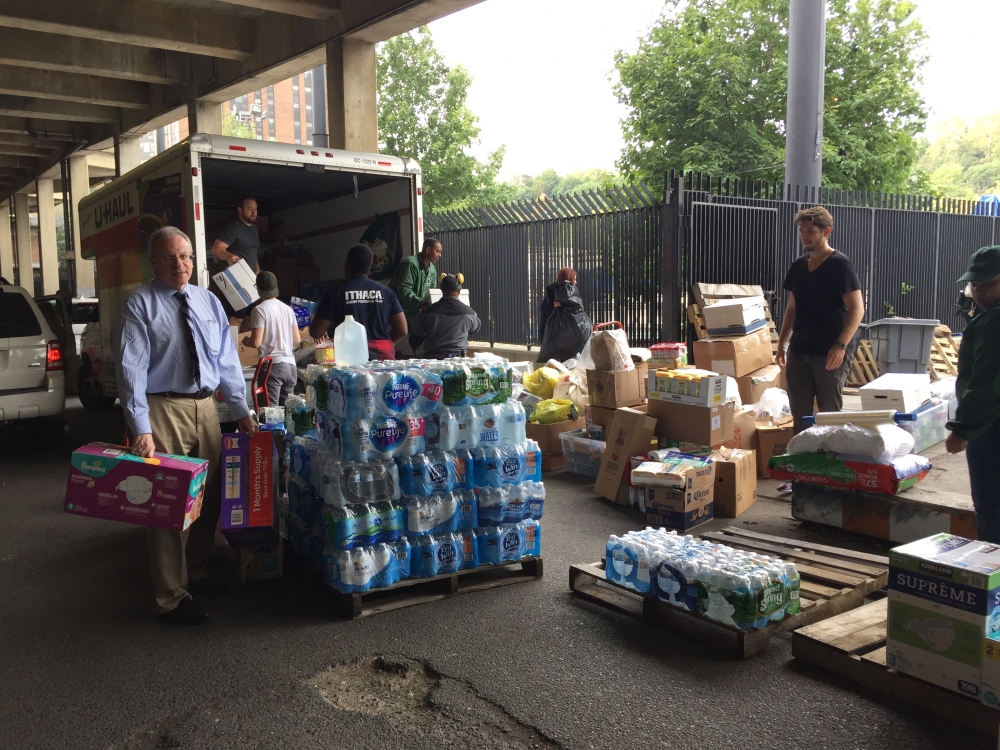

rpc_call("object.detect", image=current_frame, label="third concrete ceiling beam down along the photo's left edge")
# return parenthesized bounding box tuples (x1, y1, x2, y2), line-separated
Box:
(0, 65, 150, 109)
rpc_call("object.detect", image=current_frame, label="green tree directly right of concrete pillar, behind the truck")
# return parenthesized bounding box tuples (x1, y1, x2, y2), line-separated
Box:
(377, 26, 513, 212)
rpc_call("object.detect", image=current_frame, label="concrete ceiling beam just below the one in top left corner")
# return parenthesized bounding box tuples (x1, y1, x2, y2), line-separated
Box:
(0, 27, 190, 85)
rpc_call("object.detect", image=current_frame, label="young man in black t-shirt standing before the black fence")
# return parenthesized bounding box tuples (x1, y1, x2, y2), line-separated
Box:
(778, 206, 865, 433)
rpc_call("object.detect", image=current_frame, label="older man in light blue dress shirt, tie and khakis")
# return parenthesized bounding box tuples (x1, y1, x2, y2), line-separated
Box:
(111, 227, 256, 625)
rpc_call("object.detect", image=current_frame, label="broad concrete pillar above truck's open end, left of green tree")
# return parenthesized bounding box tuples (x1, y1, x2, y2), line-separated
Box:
(326, 39, 378, 153)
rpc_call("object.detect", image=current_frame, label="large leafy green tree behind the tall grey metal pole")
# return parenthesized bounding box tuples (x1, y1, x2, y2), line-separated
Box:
(615, 0, 926, 190)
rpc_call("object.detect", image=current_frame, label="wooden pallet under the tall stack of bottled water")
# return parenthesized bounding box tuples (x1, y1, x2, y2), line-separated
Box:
(286, 547, 543, 620)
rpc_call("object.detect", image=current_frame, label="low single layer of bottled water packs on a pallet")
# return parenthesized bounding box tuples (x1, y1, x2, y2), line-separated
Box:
(605, 527, 801, 630)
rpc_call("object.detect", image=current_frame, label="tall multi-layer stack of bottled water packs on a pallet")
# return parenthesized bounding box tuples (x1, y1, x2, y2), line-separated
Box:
(286, 359, 545, 593)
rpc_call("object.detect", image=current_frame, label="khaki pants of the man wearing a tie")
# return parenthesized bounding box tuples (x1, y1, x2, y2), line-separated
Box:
(147, 396, 222, 612)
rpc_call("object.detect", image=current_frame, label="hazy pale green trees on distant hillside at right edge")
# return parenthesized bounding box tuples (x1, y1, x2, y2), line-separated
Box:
(917, 112, 1000, 199)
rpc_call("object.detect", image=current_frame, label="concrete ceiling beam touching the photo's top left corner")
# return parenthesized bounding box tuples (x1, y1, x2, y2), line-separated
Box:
(0, 0, 254, 60)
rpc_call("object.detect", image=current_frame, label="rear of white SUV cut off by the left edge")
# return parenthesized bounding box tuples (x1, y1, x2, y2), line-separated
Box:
(0, 284, 66, 437)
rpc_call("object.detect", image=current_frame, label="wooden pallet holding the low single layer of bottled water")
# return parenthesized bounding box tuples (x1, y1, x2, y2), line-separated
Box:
(569, 527, 889, 659)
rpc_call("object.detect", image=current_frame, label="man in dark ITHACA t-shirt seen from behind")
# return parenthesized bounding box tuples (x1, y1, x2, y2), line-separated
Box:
(309, 245, 407, 359)
